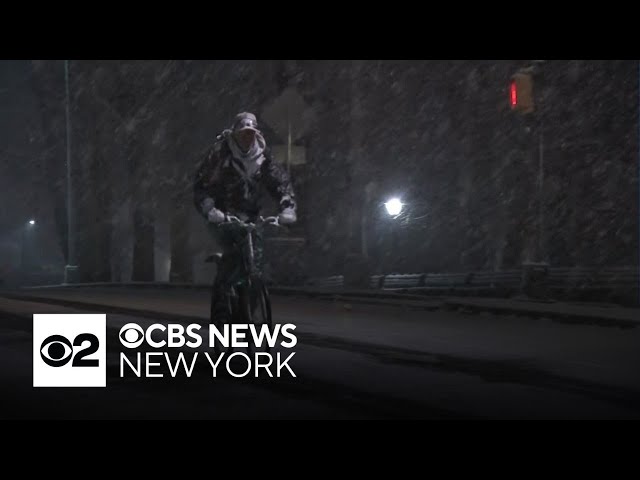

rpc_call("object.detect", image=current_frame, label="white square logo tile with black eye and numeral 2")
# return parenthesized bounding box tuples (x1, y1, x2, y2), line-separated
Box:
(33, 313, 107, 387)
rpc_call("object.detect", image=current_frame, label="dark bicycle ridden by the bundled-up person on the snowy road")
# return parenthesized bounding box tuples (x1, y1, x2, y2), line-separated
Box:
(205, 215, 280, 356)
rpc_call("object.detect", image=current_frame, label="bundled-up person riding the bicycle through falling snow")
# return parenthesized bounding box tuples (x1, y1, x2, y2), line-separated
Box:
(194, 112, 297, 324)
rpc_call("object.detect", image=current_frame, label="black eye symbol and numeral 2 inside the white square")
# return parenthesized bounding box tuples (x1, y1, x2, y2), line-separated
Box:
(40, 333, 100, 367)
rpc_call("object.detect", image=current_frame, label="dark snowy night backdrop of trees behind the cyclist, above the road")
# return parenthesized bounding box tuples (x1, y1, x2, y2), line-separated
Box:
(0, 60, 639, 292)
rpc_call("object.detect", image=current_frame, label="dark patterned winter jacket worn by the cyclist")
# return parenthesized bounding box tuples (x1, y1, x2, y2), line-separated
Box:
(193, 139, 296, 218)
